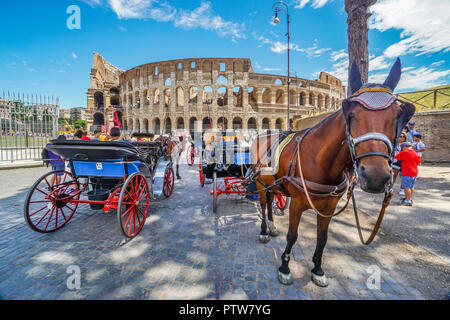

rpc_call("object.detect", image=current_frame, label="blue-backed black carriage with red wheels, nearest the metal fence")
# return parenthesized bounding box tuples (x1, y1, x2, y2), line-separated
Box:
(24, 132, 174, 238)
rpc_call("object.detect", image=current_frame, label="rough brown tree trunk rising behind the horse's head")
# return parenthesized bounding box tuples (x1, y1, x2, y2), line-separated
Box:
(345, 0, 377, 95)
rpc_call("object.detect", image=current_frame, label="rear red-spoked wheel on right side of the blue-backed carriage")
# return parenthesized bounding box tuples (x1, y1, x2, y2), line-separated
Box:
(117, 172, 150, 238)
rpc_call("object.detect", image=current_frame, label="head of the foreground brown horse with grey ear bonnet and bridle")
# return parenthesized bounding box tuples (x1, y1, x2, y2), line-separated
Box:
(342, 58, 415, 193)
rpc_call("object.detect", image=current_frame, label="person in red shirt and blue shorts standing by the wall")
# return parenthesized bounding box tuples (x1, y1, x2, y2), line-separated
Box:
(395, 142, 420, 206)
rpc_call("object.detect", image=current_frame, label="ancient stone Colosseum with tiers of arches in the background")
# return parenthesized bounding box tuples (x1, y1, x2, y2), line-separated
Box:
(86, 52, 345, 134)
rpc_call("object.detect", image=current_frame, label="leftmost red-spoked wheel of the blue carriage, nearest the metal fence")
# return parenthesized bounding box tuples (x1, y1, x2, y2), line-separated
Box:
(24, 171, 80, 233)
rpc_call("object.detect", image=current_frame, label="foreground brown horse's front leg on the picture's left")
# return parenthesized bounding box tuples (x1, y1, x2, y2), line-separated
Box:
(278, 198, 305, 285)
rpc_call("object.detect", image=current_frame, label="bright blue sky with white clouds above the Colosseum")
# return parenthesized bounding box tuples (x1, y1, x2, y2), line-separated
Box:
(0, 0, 450, 108)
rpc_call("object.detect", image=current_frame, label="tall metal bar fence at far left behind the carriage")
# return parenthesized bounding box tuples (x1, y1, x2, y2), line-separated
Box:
(0, 92, 59, 162)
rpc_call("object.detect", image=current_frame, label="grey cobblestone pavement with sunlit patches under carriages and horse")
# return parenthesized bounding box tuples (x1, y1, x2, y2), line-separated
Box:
(0, 165, 427, 299)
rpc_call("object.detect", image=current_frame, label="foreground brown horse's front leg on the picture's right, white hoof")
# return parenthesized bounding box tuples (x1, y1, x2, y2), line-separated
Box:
(311, 214, 334, 287)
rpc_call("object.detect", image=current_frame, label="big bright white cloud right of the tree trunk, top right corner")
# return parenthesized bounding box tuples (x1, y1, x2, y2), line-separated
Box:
(370, 0, 450, 58)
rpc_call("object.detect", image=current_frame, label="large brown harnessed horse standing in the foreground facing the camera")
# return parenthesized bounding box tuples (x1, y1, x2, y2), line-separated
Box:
(252, 59, 415, 287)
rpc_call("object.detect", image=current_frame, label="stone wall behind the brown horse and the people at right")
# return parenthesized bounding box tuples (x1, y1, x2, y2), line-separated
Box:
(294, 110, 450, 162)
